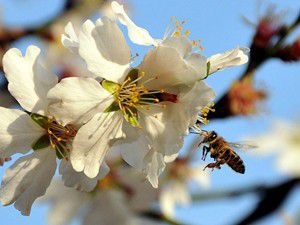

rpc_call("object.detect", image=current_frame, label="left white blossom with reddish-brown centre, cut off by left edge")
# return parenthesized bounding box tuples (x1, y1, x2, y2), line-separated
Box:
(0, 46, 107, 215)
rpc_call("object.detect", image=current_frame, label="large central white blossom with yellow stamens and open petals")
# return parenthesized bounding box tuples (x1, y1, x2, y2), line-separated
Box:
(48, 2, 214, 187)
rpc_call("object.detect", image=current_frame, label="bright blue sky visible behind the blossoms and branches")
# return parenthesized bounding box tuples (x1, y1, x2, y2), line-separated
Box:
(0, 0, 300, 225)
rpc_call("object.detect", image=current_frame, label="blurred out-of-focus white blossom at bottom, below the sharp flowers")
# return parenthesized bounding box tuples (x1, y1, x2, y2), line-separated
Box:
(41, 169, 162, 225)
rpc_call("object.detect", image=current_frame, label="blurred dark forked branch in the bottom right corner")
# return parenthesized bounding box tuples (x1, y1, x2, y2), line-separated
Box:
(193, 178, 300, 225)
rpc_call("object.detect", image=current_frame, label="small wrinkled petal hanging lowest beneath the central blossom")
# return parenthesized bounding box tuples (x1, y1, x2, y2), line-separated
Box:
(144, 150, 166, 188)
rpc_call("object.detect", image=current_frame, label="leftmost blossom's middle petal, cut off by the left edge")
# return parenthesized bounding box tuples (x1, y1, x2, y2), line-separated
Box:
(0, 107, 45, 158)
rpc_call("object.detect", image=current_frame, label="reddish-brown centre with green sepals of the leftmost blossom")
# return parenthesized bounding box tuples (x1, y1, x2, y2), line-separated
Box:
(31, 113, 77, 159)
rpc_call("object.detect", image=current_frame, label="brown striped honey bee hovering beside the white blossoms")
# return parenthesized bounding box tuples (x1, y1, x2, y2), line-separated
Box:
(198, 131, 255, 174)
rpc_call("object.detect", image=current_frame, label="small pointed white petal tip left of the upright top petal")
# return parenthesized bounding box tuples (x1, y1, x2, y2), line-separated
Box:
(61, 22, 79, 53)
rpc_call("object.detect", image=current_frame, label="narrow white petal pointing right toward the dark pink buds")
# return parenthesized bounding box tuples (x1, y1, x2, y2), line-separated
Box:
(207, 47, 249, 74)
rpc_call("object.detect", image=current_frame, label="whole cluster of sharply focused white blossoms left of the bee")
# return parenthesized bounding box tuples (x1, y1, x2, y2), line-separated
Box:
(0, 2, 248, 217)
